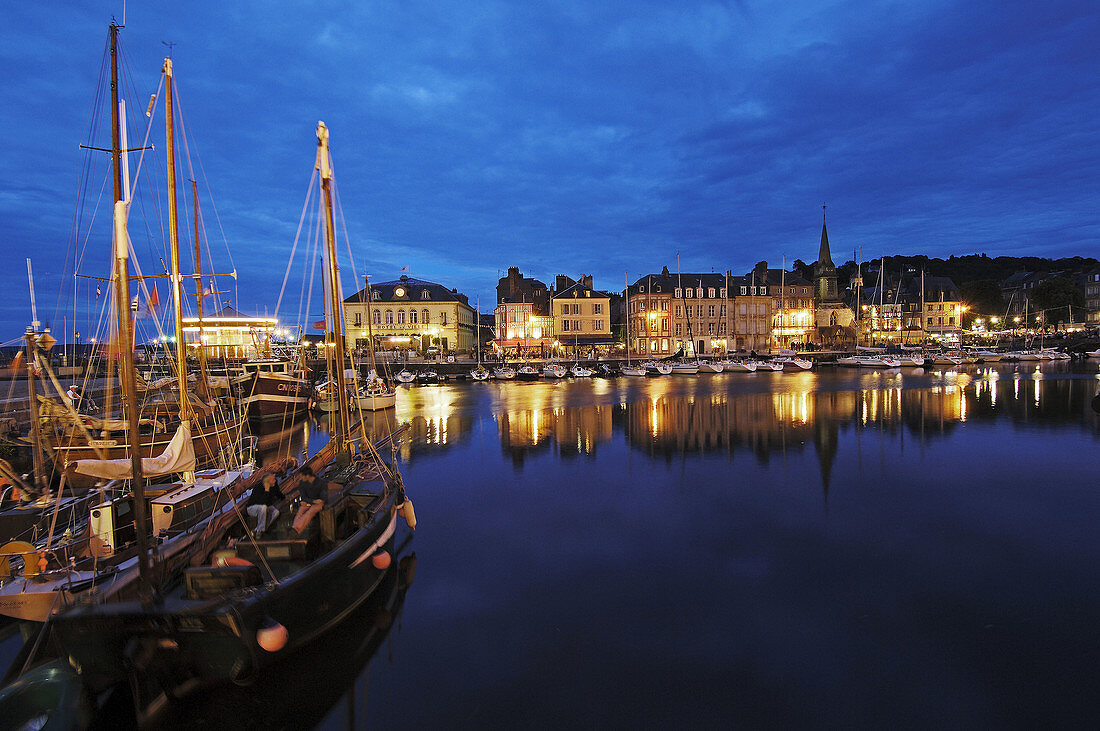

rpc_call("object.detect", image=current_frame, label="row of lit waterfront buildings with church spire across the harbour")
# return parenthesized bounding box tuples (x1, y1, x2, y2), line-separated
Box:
(178, 212, 1100, 358)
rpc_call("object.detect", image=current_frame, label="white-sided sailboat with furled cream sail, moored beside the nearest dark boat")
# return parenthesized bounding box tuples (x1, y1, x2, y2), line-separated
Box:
(0, 44, 258, 621)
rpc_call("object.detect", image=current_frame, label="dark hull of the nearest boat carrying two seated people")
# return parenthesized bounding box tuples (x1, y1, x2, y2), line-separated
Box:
(54, 483, 397, 694)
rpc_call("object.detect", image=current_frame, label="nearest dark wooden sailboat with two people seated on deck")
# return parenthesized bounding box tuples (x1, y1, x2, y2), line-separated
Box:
(53, 122, 416, 707)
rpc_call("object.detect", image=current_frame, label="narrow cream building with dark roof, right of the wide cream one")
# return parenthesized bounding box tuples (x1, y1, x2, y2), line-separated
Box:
(550, 274, 615, 357)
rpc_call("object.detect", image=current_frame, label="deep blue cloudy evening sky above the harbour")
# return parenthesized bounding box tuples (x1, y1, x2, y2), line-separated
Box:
(0, 0, 1100, 340)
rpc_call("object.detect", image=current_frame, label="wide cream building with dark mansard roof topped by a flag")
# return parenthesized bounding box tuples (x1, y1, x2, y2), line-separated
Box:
(344, 275, 477, 353)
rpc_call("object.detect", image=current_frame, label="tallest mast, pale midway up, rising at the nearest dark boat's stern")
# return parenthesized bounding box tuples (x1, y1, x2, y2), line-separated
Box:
(110, 23, 152, 601)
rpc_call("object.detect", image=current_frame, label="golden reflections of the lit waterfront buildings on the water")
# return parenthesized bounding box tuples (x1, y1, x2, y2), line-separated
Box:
(285, 366, 1097, 479)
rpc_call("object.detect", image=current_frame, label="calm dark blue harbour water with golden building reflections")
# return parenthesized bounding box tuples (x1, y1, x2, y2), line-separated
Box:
(105, 361, 1100, 729)
